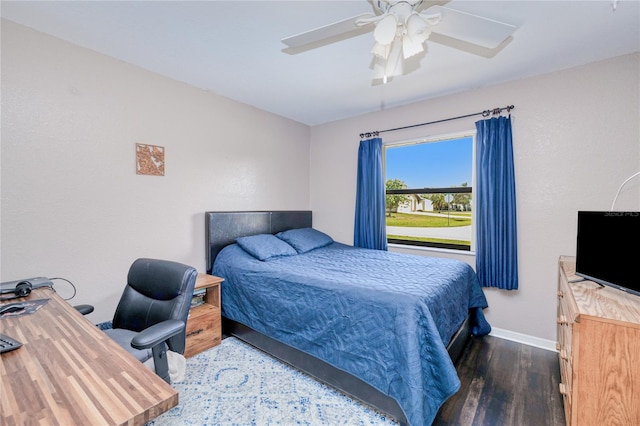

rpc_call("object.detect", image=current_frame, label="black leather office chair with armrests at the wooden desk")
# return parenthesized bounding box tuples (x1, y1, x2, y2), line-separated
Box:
(105, 259, 198, 383)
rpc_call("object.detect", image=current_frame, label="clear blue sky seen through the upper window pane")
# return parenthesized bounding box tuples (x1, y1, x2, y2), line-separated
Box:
(385, 137, 473, 188)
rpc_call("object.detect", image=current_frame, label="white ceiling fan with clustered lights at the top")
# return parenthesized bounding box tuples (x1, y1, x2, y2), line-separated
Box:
(282, 0, 516, 84)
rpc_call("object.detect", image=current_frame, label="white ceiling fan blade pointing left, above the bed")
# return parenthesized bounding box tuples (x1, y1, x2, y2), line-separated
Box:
(281, 13, 375, 55)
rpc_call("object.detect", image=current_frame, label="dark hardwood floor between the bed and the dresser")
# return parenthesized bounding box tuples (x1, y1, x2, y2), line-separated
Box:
(433, 336, 565, 426)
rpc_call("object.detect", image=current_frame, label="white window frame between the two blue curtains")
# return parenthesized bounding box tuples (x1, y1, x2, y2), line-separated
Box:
(382, 129, 476, 254)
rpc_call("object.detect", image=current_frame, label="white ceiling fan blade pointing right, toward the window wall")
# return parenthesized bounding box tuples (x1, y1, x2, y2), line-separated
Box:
(428, 6, 516, 49)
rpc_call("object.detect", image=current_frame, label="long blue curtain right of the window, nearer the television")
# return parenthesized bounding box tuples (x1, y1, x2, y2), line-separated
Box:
(475, 117, 518, 290)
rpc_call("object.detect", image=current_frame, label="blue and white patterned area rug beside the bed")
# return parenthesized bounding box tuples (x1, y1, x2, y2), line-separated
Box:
(148, 337, 398, 426)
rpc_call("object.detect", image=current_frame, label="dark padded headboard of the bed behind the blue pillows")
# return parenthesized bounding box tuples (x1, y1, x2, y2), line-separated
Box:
(204, 210, 311, 274)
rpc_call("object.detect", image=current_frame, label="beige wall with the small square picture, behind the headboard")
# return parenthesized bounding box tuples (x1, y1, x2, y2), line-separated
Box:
(0, 20, 309, 322)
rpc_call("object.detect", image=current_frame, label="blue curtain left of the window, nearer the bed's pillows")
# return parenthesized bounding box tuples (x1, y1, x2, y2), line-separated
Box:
(353, 138, 387, 250)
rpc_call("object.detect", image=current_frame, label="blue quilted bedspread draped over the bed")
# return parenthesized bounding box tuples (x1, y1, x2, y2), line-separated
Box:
(213, 243, 490, 426)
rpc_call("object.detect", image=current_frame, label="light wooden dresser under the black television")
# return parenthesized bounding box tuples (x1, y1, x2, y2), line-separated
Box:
(557, 256, 640, 426)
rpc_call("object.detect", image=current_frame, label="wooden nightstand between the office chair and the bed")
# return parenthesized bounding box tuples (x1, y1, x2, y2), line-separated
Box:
(184, 274, 224, 357)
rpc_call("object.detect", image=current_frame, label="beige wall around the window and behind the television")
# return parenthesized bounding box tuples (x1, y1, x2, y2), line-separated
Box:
(311, 54, 640, 341)
